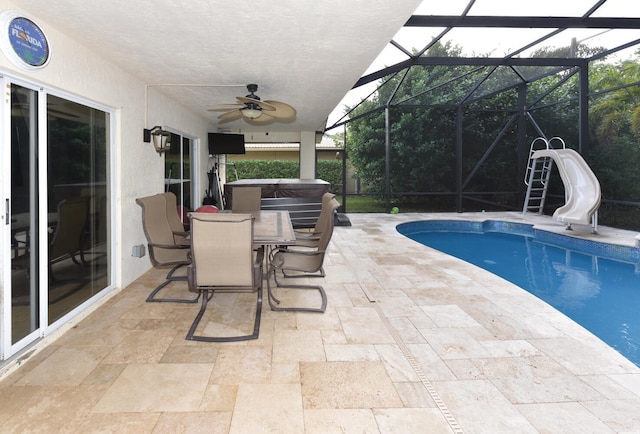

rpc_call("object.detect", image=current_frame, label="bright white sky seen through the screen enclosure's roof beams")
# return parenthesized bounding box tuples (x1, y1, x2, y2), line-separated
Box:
(327, 0, 640, 129)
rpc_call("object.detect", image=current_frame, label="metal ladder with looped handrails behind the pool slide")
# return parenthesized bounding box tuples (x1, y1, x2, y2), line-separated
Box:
(522, 137, 564, 214)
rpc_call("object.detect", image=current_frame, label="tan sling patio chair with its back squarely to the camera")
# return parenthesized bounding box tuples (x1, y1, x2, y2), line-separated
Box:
(186, 213, 264, 342)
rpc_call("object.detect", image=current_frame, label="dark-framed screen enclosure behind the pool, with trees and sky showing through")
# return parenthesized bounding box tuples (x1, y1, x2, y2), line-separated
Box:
(327, 0, 640, 229)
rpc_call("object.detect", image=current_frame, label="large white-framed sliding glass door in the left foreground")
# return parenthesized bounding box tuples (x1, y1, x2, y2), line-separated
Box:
(0, 78, 111, 360)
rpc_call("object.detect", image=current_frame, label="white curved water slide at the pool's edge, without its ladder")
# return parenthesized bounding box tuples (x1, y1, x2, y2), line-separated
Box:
(531, 149, 600, 230)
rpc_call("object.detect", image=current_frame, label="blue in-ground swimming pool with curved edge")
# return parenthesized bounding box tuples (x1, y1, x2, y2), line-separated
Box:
(397, 220, 640, 366)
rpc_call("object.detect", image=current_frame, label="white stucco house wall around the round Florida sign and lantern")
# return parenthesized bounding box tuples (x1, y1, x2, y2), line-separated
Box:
(0, 0, 211, 287)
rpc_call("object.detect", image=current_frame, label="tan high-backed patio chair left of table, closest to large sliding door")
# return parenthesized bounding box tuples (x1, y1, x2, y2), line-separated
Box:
(136, 194, 198, 303)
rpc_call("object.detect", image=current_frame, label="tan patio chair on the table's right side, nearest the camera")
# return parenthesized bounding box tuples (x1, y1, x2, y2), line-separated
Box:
(267, 198, 340, 313)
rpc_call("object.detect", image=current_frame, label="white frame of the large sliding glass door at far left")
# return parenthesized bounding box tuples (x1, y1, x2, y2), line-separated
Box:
(0, 71, 118, 360)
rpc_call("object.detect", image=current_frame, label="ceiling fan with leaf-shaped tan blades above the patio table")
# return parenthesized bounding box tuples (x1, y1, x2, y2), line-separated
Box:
(208, 84, 296, 125)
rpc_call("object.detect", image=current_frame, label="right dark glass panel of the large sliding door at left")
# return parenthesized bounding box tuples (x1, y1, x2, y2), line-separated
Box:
(47, 95, 110, 324)
